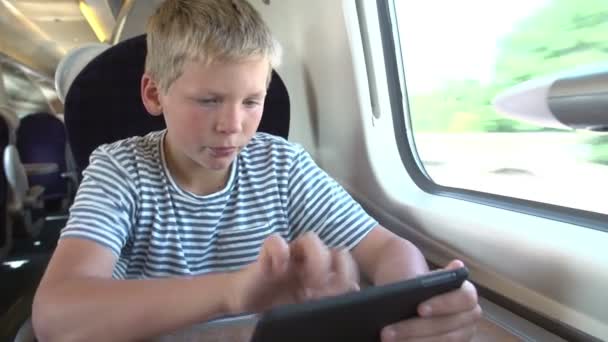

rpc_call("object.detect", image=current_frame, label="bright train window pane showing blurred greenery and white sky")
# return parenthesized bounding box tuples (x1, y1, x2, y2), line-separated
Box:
(394, 0, 608, 214)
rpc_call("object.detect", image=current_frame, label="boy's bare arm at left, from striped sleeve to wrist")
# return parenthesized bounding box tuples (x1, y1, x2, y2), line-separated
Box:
(33, 238, 233, 341)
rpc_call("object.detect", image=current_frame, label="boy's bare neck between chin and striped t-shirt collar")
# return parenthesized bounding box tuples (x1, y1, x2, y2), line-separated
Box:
(163, 137, 231, 196)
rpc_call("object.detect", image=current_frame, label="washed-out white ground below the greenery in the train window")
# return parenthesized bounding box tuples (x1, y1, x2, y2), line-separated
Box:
(416, 133, 608, 214)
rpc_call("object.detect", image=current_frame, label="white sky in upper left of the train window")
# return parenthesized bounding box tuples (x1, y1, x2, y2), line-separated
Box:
(395, 0, 551, 93)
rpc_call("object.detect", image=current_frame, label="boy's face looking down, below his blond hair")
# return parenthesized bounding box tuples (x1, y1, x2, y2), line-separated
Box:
(143, 58, 270, 172)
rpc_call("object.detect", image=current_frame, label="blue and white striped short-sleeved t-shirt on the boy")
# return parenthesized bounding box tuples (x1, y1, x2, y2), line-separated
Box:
(61, 131, 377, 279)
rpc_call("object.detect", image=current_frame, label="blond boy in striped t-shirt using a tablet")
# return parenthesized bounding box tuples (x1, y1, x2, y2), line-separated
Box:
(33, 0, 480, 341)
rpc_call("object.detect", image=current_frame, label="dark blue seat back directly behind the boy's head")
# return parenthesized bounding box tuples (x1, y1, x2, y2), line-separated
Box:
(64, 35, 290, 175)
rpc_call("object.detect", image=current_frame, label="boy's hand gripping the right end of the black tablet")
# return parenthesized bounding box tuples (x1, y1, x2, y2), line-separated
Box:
(381, 260, 481, 342)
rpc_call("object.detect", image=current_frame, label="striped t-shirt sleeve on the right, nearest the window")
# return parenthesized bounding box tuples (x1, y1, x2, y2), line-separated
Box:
(288, 149, 378, 249)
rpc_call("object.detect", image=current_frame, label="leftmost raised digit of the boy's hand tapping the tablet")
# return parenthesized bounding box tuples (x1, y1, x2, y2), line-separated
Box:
(258, 234, 289, 278)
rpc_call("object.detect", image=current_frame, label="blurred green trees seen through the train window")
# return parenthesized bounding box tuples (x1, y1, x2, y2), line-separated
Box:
(409, 0, 608, 164)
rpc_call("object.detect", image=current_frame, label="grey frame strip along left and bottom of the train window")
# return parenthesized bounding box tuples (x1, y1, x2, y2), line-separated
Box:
(376, 0, 608, 233)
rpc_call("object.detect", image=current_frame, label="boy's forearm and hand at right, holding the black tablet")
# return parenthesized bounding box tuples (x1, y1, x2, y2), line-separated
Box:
(352, 225, 481, 342)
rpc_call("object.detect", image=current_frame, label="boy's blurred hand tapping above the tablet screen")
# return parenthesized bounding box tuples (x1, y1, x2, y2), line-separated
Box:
(231, 233, 359, 313)
